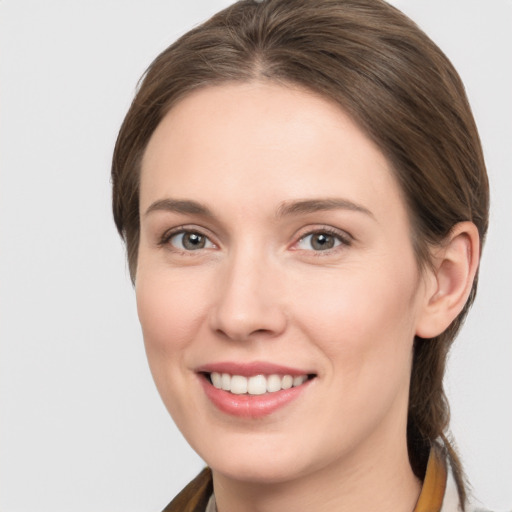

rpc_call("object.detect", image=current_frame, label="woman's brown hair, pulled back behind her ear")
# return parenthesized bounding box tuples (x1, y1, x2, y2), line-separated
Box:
(112, 0, 489, 502)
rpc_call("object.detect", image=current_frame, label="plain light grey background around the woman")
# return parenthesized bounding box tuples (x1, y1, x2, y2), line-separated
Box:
(0, 0, 512, 512)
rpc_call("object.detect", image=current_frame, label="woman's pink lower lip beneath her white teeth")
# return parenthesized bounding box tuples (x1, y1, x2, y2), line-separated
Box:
(200, 376, 311, 418)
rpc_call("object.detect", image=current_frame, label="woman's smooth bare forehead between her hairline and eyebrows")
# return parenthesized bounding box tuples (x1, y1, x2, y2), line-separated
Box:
(141, 82, 401, 220)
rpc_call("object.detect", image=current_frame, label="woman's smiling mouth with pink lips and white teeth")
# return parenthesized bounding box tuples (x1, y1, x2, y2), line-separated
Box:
(196, 362, 315, 418)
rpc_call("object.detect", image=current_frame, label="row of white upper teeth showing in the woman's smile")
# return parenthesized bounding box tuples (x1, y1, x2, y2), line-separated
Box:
(210, 372, 308, 395)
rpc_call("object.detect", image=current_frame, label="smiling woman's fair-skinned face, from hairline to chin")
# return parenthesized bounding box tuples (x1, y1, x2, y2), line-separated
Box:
(136, 83, 427, 482)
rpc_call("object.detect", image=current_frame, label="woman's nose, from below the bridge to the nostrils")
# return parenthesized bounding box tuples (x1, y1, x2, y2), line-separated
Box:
(210, 249, 287, 341)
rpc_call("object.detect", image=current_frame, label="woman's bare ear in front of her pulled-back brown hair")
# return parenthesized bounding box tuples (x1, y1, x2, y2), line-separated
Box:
(416, 222, 480, 338)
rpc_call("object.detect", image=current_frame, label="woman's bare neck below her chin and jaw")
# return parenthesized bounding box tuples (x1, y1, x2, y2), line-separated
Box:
(213, 432, 421, 512)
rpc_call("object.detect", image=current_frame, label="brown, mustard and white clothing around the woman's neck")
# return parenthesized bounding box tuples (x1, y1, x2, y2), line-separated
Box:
(163, 447, 490, 512)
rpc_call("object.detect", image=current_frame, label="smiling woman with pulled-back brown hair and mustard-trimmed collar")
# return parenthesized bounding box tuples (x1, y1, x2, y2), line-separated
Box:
(112, 0, 488, 512)
